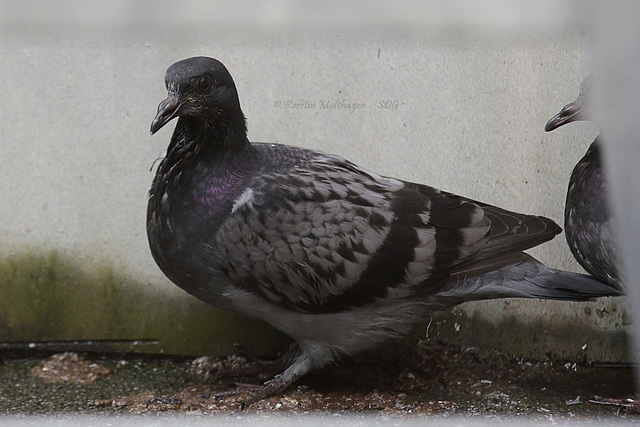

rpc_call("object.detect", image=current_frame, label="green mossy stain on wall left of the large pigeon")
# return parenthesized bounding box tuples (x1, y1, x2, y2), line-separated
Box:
(0, 251, 287, 355)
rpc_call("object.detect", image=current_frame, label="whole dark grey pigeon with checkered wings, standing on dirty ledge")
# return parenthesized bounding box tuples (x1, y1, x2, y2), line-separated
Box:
(147, 57, 620, 407)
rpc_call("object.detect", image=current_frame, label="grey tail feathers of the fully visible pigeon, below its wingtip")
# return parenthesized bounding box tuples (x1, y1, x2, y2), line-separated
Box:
(438, 253, 624, 306)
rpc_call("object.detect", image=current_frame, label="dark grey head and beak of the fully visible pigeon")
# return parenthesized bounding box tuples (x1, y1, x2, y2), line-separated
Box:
(151, 56, 246, 135)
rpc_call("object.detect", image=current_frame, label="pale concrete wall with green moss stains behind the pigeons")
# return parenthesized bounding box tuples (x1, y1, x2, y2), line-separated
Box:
(0, 10, 630, 361)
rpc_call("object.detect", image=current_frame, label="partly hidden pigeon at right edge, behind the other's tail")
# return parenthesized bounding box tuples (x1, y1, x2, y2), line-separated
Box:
(545, 75, 623, 290)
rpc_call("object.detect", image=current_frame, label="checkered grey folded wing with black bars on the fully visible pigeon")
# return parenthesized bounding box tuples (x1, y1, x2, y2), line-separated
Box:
(215, 145, 557, 313)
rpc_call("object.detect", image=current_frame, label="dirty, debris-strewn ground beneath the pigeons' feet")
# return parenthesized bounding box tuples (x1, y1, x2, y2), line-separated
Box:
(0, 339, 640, 423)
